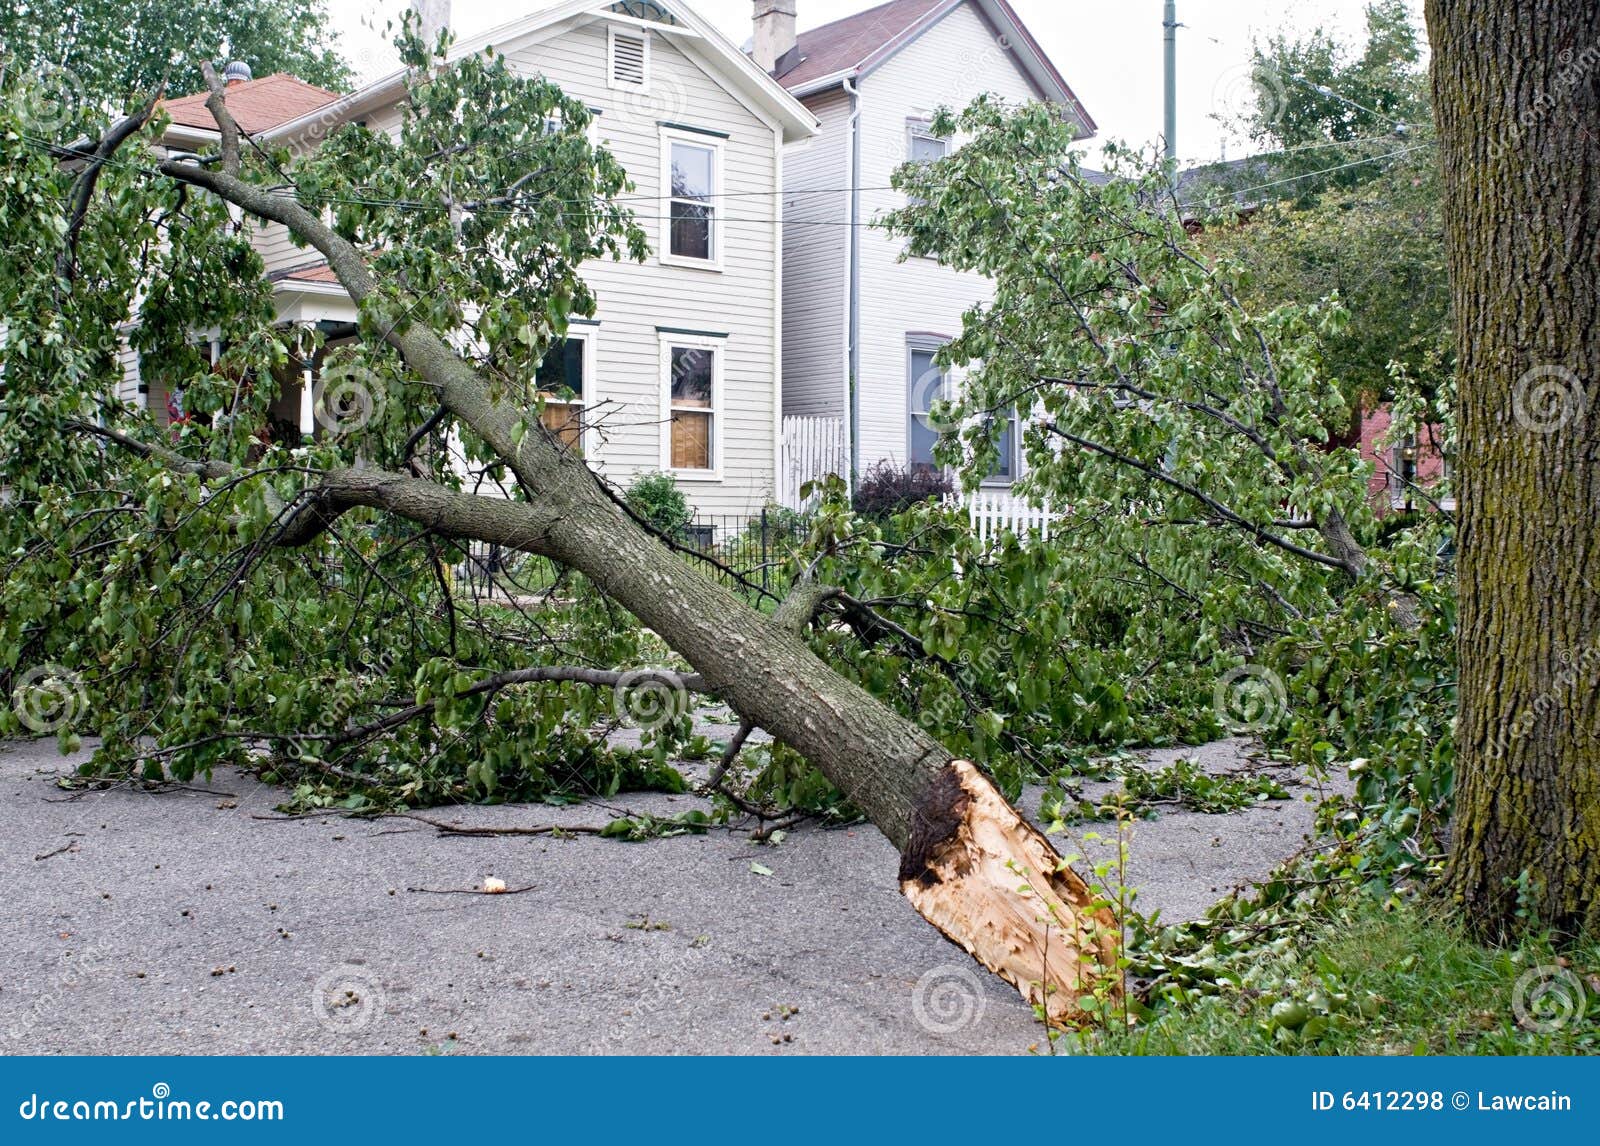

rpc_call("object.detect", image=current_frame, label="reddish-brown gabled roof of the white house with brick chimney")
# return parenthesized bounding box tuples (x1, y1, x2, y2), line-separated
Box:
(778, 0, 1096, 139)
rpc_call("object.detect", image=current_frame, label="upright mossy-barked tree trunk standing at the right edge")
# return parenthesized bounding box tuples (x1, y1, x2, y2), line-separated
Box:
(1427, 0, 1600, 936)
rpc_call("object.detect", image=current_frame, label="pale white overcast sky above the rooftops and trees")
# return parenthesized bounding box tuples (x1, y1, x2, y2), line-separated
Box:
(328, 0, 1421, 165)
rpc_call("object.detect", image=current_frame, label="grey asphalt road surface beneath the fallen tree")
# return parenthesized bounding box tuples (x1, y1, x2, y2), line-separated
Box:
(0, 741, 1331, 1055)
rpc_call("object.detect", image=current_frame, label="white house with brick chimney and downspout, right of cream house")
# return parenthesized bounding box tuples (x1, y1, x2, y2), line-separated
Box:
(754, 0, 1094, 483)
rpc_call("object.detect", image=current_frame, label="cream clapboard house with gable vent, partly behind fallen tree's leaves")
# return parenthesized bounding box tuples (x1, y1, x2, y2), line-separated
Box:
(131, 0, 816, 515)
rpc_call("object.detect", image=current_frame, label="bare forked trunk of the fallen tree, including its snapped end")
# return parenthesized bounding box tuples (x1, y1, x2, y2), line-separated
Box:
(162, 159, 1120, 1024)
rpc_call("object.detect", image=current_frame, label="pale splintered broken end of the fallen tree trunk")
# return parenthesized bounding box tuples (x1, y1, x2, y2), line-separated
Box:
(901, 760, 1122, 1026)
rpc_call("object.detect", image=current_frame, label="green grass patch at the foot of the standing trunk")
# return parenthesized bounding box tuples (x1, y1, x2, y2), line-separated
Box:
(1075, 904, 1600, 1055)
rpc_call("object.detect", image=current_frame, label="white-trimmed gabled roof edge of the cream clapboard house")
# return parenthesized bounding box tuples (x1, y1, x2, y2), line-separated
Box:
(274, 0, 818, 142)
